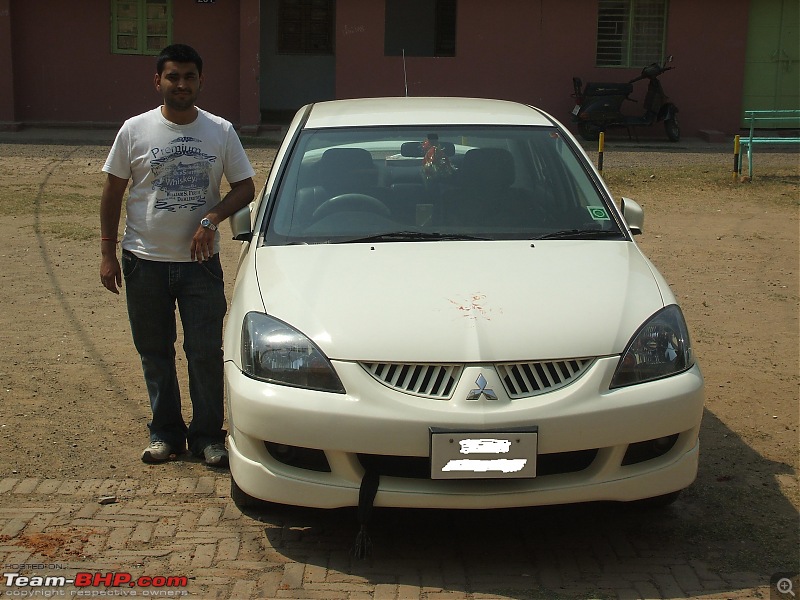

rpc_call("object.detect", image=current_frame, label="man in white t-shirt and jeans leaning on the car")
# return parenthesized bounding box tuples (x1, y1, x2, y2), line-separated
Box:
(100, 44, 255, 467)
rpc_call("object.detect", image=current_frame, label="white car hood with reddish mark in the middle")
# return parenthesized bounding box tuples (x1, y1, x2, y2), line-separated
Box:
(256, 240, 668, 362)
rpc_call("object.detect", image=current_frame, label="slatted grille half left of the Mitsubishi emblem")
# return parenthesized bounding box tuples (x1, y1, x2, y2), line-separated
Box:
(361, 363, 464, 400)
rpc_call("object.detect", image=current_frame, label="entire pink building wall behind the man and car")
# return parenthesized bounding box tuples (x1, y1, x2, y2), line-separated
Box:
(0, 0, 750, 137)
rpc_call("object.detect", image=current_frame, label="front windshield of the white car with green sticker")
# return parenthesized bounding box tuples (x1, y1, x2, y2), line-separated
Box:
(263, 126, 626, 245)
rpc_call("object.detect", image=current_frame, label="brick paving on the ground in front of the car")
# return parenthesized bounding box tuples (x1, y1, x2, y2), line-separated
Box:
(0, 472, 770, 600)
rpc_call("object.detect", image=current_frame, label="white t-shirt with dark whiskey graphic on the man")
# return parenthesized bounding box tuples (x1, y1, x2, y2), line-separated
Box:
(103, 107, 255, 262)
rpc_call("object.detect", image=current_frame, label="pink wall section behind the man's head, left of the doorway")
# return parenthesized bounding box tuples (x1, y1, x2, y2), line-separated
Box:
(0, 0, 259, 125)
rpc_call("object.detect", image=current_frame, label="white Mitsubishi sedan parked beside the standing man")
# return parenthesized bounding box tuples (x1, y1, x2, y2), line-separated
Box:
(224, 98, 703, 508)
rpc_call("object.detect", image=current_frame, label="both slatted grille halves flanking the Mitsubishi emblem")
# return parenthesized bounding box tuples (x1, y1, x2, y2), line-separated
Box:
(361, 358, 594, 400)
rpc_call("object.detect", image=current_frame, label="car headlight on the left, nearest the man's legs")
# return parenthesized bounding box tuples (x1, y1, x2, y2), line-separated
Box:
(242, 312, 344, 394)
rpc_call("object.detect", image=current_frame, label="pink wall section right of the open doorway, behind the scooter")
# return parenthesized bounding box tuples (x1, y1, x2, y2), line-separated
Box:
(336, 0, 748, 136)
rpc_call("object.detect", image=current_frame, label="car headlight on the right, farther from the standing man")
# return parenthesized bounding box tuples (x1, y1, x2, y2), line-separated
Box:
(610, 304, 694, 388)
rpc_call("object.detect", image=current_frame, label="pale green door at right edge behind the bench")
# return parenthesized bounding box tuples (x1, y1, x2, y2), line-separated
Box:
(742, 0, 800, 127)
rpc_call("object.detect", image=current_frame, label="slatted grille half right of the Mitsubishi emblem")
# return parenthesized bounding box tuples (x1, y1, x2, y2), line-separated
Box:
(496, 358, 594, 399)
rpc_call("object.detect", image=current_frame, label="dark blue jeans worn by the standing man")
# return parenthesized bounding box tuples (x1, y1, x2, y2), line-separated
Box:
(122, 251, 227, 456)
